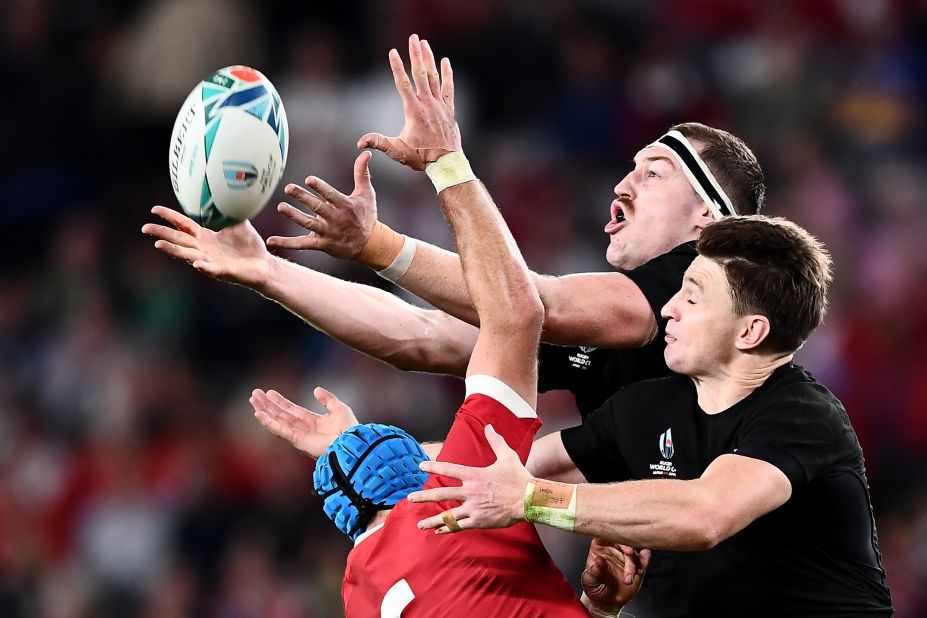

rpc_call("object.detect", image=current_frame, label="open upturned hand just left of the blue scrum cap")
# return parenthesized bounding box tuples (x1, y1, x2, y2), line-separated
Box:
(248, 387, 357, 459)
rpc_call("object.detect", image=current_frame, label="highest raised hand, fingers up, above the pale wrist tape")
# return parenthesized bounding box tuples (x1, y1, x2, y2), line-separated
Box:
(357, 34, 462, 171)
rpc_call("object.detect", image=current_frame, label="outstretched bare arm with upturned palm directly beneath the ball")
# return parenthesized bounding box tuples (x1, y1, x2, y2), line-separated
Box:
(142, 202, 477, 376)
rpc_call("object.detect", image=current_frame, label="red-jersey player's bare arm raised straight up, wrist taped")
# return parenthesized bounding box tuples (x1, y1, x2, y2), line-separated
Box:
(374, 37, 544, 400)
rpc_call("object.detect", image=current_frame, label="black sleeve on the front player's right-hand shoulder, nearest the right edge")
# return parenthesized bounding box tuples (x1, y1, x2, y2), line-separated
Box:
(734, 399, 858, 490)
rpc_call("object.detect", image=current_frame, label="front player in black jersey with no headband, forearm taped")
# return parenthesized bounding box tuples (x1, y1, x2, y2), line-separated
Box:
(409, 216, 893, 617)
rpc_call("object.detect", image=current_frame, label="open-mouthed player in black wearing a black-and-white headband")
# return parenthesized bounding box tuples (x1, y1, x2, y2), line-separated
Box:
(143, 36, 765, 415)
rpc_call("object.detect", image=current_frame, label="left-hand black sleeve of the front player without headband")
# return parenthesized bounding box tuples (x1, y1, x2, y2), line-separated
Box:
(560, 393, 631, 483)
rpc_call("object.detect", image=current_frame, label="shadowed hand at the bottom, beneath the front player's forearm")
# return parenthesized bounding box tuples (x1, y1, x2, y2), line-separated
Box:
(581, 538, 650, 612)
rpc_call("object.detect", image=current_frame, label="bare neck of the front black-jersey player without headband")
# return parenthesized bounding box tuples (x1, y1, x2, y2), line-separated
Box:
(692, 354, 793, 414)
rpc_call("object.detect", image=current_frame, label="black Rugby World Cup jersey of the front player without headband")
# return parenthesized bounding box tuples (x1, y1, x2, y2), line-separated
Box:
(562, 364, 892, 617)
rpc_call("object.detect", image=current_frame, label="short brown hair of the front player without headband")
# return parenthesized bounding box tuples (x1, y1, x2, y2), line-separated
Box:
(697, 215, 832, 353)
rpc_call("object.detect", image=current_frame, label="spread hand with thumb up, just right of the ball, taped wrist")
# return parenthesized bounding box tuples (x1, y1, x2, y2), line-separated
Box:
(267, 151, 377, 259)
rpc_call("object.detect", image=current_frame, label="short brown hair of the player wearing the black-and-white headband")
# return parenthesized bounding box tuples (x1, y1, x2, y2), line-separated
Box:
(670, 122, 766, 215)
